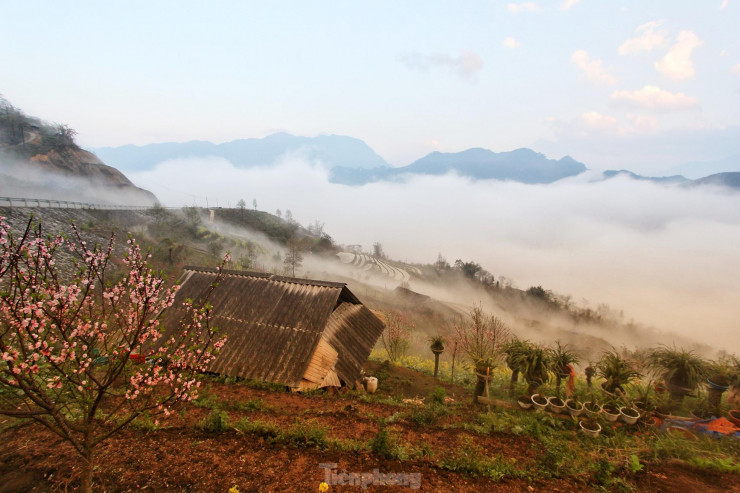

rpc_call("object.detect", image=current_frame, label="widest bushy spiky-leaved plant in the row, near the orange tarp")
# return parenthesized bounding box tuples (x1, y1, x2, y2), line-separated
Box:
(648, 346, 708, 409)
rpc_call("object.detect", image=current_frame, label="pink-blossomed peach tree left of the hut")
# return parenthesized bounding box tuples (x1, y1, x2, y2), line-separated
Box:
(0, 217, 228, 492)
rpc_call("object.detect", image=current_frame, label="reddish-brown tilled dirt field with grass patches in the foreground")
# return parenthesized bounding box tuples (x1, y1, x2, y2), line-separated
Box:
(0, 383, 740, 493)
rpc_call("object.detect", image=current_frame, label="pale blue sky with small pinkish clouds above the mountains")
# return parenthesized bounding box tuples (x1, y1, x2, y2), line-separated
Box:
(0, 0, 740, 175)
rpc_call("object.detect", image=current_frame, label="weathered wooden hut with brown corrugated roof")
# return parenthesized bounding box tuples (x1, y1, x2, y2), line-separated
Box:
(163, 267, 384, 390)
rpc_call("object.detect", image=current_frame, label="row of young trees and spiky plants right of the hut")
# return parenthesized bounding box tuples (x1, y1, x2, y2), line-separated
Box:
(381, 306, 740, 409)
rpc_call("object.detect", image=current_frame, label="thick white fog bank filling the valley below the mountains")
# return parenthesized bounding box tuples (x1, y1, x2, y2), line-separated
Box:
(130, 158, 740, 352)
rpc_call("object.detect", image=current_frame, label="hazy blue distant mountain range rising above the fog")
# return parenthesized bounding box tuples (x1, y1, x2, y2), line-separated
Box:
(94, 133, 740, 188)
